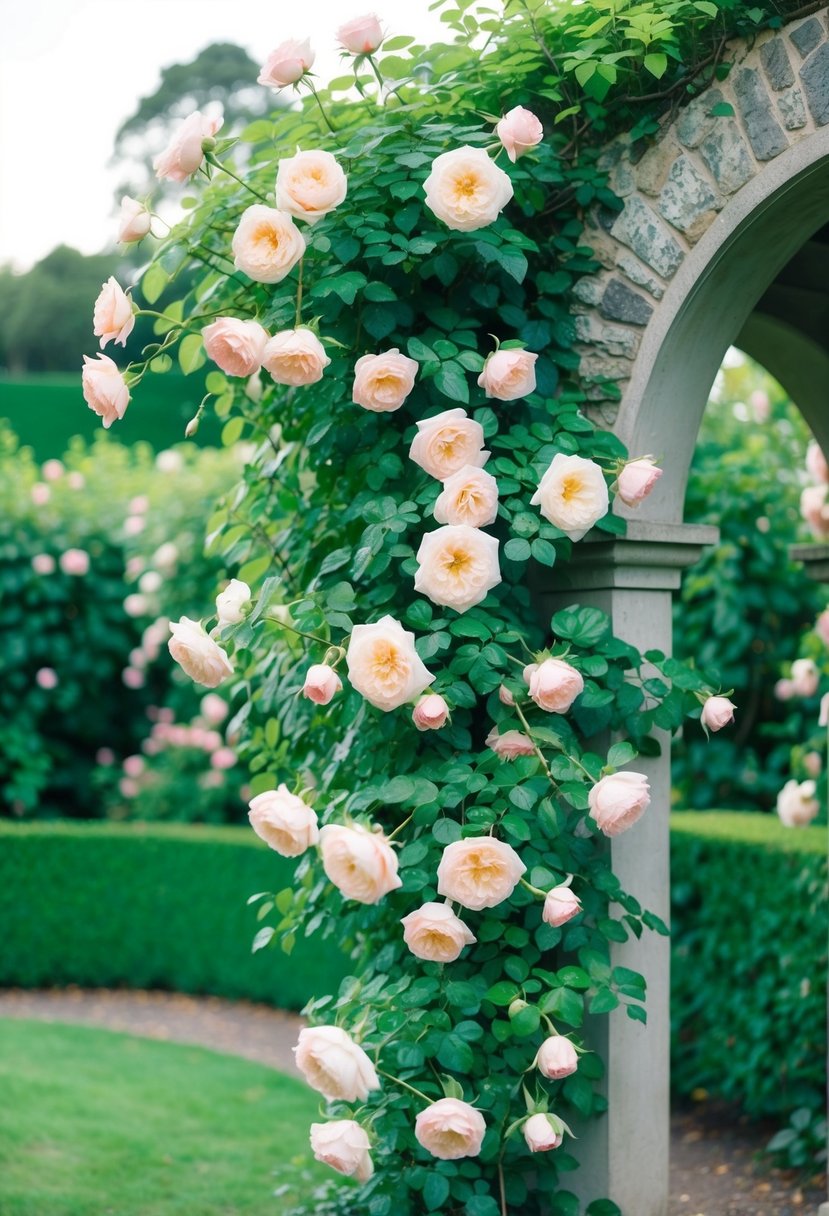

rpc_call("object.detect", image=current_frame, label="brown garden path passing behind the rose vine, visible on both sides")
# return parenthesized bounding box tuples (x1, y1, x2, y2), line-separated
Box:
(0, 987, 825, 1216)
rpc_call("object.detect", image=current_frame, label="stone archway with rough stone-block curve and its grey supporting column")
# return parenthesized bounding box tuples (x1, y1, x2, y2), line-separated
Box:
(549, 10, 829, 1216)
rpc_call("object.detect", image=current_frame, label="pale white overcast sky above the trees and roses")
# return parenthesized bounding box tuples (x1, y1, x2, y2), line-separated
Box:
(0, 0, 445, 270)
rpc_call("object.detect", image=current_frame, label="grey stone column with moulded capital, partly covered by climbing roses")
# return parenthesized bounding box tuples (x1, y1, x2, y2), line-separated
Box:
(540, 520, 718, 1216)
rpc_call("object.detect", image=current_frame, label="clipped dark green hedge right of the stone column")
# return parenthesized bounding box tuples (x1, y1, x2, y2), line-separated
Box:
(671, 812, 829, 1166)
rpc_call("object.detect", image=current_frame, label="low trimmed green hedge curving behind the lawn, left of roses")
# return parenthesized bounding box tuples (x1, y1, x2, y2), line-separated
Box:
(0, 822, 346, 1009)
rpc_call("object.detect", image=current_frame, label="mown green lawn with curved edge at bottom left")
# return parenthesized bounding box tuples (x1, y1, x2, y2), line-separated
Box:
(0, 1019, 331, 1216)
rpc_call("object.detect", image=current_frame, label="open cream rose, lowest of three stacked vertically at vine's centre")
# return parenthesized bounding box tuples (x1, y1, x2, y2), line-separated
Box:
(415, 524, 501, 612)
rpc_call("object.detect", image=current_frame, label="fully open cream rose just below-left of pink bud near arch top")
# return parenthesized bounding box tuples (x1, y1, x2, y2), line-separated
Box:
(423, 146, 513, 232)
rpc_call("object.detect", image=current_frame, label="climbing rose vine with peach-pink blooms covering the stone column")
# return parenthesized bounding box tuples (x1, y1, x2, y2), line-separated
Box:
(84, 6, 727, 1216)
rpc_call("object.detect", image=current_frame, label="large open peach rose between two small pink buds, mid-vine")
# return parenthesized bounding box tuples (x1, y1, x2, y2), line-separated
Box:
(345, 615, 434, 710)
